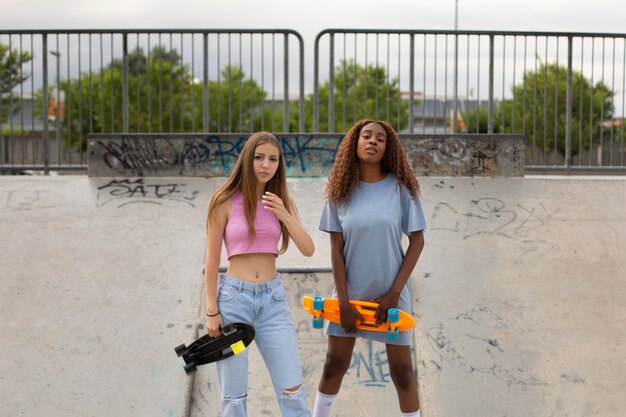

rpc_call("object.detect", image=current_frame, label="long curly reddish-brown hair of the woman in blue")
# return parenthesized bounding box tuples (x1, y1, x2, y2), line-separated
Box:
(326, 119, 420, 204)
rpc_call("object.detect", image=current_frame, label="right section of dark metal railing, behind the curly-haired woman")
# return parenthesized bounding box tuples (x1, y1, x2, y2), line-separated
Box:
(312, 29, 626, 172)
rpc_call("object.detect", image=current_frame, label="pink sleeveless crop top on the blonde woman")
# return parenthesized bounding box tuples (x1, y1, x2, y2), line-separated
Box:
(224, 191, 282, 259)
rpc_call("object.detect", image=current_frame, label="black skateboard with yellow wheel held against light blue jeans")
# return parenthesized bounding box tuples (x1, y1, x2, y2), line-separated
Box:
(174, 323, 254, 375)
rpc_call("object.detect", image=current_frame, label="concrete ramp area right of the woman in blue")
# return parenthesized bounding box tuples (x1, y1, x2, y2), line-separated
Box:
(414, 178, 626, 417)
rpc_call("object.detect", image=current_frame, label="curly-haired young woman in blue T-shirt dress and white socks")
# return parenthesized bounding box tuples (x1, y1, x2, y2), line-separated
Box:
(313, 120, 426, 417)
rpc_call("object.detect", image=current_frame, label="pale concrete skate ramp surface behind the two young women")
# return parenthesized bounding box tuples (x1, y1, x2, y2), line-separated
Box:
(0, 176, 626, 417)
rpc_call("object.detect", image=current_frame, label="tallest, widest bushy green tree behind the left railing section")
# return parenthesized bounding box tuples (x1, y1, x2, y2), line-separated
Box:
(47, 47, 193, 148)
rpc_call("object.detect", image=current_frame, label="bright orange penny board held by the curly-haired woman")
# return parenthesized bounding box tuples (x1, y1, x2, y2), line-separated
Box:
(302, 295, 415, 332)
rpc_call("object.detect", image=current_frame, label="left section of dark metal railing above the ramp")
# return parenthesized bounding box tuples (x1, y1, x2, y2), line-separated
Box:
(0, 29, 304, 173)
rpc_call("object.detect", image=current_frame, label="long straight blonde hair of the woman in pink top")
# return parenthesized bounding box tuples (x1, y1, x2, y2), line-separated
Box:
(207, 132, 297, 253)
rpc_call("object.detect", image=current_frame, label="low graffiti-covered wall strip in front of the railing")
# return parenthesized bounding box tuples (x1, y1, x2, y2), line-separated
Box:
(88, 134, 525, 177)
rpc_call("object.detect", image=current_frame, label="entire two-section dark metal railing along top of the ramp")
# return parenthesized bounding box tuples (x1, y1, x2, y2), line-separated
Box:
(0, 29, 626, 173)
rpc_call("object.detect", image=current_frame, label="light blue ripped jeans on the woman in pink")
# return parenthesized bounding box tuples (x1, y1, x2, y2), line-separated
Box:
(217, 274, 311, 417)
